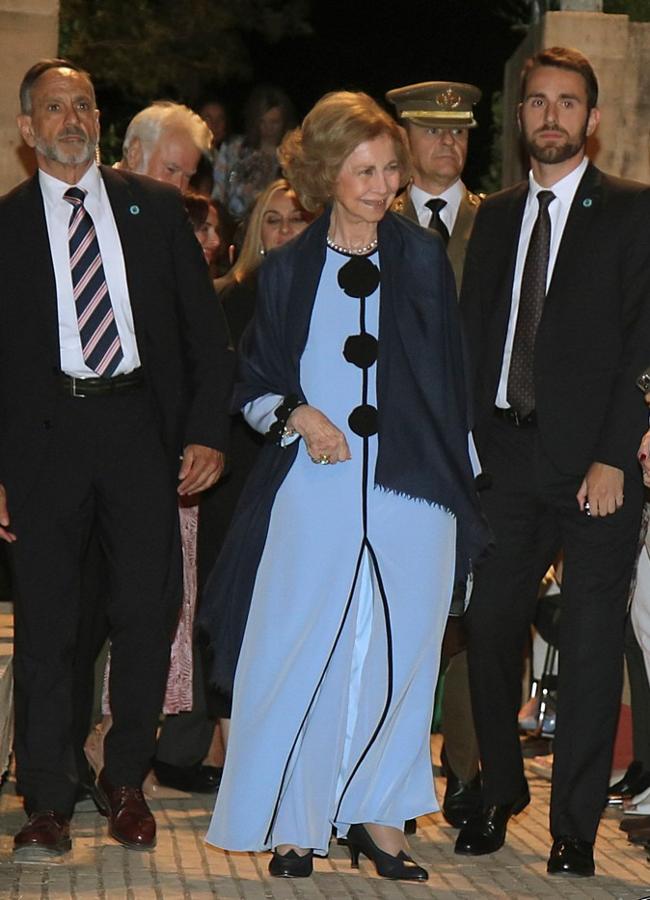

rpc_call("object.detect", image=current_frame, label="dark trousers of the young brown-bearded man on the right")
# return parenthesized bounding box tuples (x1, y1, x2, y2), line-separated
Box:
(467, 421, 643, 841)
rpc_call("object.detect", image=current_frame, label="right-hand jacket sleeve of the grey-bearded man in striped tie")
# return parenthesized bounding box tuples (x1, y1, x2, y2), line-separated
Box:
(172, 194, 235, 452)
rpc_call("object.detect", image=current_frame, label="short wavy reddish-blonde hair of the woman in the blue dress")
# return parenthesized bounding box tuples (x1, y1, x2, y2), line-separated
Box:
(278, 91, 411, 212)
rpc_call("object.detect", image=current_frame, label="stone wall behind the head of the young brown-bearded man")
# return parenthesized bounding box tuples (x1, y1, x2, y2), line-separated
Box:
(502, 12, 650, 187)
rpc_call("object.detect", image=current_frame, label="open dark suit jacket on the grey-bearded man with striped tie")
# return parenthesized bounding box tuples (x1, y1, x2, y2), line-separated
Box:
(0, 166, 234, 509)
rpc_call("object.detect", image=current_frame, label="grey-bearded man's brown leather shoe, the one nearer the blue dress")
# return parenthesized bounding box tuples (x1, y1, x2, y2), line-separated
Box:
(95, 770, 156, 850)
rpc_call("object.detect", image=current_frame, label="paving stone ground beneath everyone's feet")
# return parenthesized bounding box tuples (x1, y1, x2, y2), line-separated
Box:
(0, 756, 650, 900)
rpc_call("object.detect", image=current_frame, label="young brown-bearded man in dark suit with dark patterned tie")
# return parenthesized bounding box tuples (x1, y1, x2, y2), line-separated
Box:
(456, 48, 650, 875)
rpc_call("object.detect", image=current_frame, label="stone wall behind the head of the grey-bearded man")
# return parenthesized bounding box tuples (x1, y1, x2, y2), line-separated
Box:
(0, 0, 59, 194)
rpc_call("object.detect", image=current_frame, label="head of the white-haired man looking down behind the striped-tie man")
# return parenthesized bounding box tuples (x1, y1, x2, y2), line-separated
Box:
(119, 100, 212, 191)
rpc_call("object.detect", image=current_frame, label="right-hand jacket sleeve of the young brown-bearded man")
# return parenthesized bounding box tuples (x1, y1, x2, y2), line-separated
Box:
(585, 190, 650, 472)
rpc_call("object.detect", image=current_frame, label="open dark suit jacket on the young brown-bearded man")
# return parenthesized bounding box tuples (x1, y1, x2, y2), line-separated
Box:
(460, 165, 650, 478)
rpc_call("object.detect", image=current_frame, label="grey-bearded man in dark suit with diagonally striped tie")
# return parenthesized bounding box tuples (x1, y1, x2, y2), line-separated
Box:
(0, 60, 232, 860)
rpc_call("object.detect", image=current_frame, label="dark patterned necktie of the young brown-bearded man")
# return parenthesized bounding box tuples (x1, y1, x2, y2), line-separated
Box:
(508, 191, 555, 416)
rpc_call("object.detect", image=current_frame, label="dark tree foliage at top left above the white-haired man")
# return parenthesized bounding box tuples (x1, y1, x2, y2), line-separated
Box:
(59, 0, 309, 106)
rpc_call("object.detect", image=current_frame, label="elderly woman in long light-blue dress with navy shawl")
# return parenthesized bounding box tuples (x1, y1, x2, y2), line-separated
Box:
(204, 92, 487, 881)
